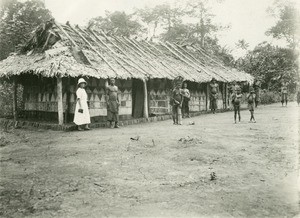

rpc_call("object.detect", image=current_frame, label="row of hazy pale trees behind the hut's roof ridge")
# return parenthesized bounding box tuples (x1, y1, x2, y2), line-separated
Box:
(88, 0, 233, 65)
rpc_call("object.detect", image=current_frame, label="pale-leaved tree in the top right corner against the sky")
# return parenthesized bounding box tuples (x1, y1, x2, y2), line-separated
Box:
(266, 2, 300, 49)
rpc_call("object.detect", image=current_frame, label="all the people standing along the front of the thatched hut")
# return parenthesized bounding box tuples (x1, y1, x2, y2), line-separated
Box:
(74, 78, 294, 131)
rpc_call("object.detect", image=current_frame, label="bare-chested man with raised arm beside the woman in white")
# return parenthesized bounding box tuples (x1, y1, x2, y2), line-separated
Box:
(105, 78, 120, 128)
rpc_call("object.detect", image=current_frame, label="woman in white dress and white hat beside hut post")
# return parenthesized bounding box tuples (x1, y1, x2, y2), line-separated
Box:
(74, 78, 91, 131)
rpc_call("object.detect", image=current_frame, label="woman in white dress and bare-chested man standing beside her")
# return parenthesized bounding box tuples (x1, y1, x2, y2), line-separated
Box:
(74, 78, 120, 131)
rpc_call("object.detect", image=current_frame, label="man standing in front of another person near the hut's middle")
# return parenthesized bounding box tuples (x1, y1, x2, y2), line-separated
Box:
(171, 82, 183, 125)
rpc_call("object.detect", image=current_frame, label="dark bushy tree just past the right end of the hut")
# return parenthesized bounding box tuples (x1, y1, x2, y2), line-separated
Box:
(236, 42, 299, 91)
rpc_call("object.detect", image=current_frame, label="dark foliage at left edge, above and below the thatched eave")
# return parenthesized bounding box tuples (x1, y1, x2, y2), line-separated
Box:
(0, 0, 51, 116)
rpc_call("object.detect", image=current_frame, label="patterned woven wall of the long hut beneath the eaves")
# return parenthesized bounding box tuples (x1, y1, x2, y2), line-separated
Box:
(21, 75, 228, 121)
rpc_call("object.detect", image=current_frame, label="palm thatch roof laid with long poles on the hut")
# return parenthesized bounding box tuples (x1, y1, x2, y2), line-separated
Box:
(0, 20, 253, 82)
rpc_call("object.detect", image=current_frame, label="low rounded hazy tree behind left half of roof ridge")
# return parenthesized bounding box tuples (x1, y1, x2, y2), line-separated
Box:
(88, 11, 143, 37)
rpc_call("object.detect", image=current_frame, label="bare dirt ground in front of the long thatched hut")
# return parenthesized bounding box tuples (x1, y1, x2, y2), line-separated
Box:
(0, 103, 300, 217)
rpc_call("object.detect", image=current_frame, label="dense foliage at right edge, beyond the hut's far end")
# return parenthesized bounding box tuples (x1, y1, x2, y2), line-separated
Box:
(235, 1, 300, 93)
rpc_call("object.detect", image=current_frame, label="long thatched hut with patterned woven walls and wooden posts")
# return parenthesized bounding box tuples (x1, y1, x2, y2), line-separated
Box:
(0, 20, 253, 124)
